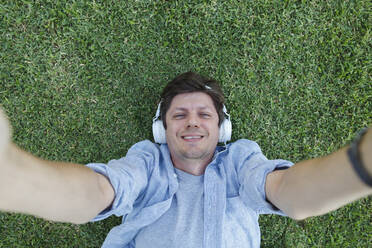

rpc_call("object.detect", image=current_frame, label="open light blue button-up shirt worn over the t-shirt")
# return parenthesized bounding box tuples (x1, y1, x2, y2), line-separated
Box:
(87, 139, 292, 248)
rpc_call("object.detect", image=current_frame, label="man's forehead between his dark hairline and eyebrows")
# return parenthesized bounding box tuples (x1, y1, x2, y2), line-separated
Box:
(169, 92, 215, 111)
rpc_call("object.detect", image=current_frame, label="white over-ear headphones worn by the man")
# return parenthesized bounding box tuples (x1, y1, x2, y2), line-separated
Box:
(152, 102, 232, 144)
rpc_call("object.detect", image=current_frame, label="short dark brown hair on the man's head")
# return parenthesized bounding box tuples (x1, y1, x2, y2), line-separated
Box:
(160, 71, 225, 128)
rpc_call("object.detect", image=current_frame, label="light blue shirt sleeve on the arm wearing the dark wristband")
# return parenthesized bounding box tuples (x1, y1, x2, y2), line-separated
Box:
(238, 141, 293, 215)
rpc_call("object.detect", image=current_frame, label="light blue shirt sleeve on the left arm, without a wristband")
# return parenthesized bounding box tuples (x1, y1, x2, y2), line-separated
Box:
(86, 141, 152, 222)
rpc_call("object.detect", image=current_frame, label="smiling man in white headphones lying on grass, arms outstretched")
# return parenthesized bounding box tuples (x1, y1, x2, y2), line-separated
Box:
(0, 72, 372, 248)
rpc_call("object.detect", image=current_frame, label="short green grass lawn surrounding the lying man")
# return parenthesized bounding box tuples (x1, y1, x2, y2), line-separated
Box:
(0, 0, 372, 247)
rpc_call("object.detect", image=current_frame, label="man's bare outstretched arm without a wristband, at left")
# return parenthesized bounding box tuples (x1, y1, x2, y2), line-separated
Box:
(0, 107, 114, 224)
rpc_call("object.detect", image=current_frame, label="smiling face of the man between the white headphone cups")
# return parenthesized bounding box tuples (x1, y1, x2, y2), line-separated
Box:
(165, 92, 219, 163)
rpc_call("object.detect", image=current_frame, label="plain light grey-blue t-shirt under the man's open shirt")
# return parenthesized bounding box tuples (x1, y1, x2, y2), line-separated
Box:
(135, 169, 204, 248)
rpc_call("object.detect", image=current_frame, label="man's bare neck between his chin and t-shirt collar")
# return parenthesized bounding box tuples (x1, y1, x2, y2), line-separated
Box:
(171, 154, 213, 176)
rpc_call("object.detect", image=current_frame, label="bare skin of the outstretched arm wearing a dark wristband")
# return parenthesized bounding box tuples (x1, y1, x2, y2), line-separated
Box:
(265, 128, 372, 219)
